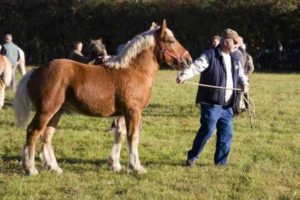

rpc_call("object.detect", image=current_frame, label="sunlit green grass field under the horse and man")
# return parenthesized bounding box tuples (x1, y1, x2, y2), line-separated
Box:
(0, 70, 300, 200)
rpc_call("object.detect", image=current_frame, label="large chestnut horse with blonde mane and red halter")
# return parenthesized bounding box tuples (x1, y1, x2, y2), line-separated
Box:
(14, 20, 192, 175)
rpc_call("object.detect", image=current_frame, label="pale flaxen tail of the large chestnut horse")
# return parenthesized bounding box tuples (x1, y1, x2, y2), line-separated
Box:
(13, 70, 34, 127)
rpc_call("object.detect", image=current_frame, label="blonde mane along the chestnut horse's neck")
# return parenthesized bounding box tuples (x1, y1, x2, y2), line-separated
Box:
(104, 29, 157, 69)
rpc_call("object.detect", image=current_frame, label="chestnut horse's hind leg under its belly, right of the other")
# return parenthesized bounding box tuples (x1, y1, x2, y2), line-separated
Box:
(40, 110, 63, 174)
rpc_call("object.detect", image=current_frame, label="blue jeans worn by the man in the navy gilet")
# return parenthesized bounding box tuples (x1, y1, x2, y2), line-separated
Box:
(188, 104, 233, 165)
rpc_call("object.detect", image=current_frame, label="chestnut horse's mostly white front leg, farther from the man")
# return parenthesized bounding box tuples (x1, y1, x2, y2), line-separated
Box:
(108, 116, 126, 172)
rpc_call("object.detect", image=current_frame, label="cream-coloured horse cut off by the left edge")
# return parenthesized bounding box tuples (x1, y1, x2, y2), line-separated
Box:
(0, 54, 12, 109)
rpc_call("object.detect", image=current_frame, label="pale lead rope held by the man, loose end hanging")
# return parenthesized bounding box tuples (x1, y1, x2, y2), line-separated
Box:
(185, 81, 255, 128)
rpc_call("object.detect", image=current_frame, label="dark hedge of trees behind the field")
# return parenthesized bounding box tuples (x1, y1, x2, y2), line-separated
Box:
(0, 0, 300, 69)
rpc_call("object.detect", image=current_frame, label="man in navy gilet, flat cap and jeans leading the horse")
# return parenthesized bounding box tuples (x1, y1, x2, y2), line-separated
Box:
(176, 29, 248, 166)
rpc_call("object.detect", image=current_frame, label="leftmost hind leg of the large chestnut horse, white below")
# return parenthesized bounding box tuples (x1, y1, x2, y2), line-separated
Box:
(22, 112, 52, 175)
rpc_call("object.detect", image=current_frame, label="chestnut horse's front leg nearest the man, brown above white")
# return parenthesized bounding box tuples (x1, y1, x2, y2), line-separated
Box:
(125, 111, 147, 173)
